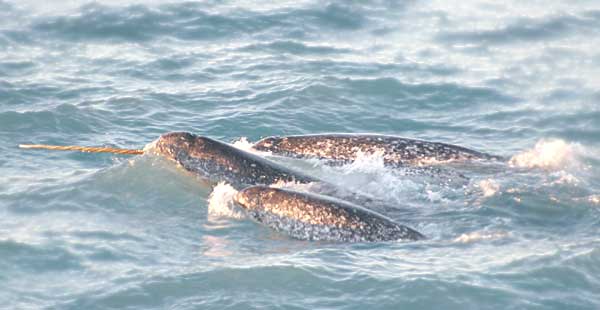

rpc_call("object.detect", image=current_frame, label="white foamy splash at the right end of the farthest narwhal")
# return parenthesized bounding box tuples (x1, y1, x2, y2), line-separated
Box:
(509, 139, 576, 169)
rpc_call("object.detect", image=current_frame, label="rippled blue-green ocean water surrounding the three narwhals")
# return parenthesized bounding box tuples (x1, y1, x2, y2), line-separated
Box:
(0, 0, 600, 309)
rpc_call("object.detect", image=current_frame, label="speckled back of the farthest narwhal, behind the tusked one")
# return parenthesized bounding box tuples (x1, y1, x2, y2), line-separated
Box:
(253, 134, 503, 166)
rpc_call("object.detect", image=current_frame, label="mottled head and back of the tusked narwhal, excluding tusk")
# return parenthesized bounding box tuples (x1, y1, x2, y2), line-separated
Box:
(151, 132, 321, 190)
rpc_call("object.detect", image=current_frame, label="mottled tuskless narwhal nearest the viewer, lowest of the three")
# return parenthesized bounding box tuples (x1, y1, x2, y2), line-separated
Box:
(234, 186, 425, 242)
